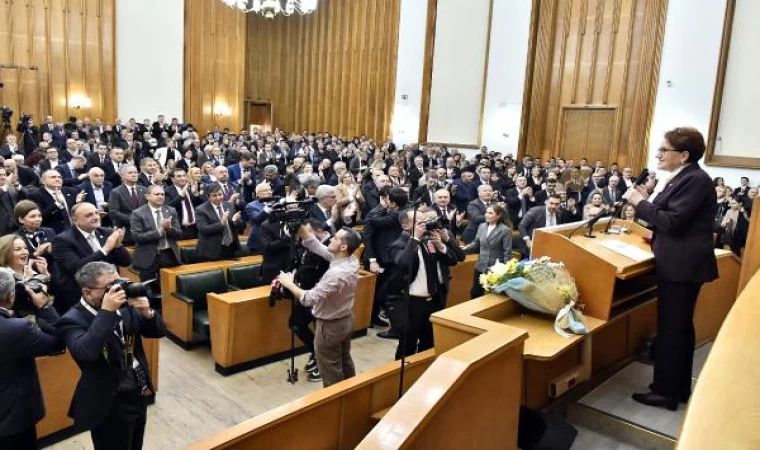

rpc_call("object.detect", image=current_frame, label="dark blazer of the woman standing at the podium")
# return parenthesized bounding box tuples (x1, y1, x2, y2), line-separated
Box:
(636, 163, 718, 283)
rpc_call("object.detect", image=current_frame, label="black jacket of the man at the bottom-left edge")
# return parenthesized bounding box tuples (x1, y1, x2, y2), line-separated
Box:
(0, 308, 63, 436)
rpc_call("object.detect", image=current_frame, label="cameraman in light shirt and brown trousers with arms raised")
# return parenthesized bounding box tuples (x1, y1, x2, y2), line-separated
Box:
(277, 226, 361, 387)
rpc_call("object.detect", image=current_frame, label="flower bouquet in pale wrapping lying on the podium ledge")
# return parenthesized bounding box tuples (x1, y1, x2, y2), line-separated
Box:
(480, 256, 588, 337)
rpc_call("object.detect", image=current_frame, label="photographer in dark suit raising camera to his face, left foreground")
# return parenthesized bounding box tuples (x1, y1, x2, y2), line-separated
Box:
(57, 261, 166, 450)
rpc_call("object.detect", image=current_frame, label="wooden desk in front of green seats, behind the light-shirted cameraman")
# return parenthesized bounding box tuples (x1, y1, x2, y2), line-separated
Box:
(207, 271, 376, 375)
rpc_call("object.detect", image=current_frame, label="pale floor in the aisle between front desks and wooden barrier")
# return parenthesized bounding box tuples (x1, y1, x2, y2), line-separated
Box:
(48, 329, 398, 450)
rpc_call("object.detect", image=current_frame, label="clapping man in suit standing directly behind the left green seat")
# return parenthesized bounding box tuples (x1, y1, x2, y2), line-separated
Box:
(195, 183, 245, 261)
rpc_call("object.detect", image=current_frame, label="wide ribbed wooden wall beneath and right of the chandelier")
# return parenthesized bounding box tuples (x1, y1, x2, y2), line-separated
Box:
(246, 0, 400, 139)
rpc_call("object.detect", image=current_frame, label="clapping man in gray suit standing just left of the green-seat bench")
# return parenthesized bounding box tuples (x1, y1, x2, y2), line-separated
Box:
(130, 184, 182, 292)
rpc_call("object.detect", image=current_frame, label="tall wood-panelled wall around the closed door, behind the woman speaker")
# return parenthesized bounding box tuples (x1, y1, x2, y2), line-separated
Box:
(519, 0, 667, 170)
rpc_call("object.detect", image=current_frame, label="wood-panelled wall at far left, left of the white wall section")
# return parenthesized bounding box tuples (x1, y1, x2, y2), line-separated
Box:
(0, 0, 116, 130)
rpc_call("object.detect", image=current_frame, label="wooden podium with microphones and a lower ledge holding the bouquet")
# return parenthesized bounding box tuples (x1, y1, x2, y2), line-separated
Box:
(431, 220, 740, 408)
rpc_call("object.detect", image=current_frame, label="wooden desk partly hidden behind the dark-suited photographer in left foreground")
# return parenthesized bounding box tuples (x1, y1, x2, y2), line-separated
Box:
(37, 339, 160, 438)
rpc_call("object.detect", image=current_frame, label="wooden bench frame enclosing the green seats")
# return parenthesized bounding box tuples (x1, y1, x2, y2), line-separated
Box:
(160, 255, 261, 344)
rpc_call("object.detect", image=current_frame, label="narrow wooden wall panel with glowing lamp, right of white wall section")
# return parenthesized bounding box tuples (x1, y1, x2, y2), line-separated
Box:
(184, 0, 246, 131)
